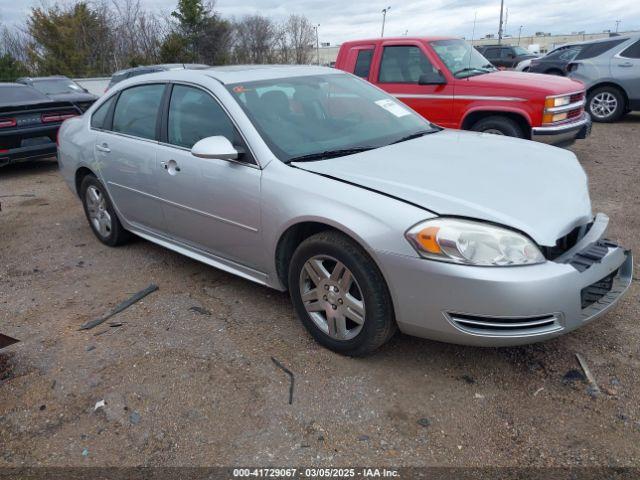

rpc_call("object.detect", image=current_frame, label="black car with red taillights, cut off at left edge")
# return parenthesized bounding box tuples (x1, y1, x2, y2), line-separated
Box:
(0, 83, 82, 167)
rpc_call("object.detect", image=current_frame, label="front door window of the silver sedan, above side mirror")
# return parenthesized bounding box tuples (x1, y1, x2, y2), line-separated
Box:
(167, 85, 241, 148)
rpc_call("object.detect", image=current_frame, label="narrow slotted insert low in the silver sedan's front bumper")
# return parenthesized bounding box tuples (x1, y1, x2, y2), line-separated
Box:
(449, 313, 562, 337)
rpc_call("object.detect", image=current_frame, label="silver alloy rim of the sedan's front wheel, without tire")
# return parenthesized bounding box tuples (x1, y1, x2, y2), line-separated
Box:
(299, 255, 366, 341)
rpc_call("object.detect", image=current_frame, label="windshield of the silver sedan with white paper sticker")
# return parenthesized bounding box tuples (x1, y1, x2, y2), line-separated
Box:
(227, 74, 438, 162)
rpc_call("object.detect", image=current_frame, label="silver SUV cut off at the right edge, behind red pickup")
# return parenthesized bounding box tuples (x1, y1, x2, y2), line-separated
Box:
(567, 35, 640, 122)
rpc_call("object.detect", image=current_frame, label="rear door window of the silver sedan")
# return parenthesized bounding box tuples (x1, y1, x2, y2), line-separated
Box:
(113, 84, 165, 140)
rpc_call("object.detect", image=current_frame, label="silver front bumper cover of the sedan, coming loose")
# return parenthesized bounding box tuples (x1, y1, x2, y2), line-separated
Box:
(378, 214, 633, 346)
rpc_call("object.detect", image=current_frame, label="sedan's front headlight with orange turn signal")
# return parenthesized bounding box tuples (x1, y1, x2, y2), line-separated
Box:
(405, 218, 545, 266)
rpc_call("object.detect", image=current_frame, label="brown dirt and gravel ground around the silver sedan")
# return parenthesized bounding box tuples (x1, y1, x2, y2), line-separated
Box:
(0, 115, 640, 466)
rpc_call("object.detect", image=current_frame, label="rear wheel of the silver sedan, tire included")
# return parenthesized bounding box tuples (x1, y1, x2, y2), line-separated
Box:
(80, 175, 131, 247)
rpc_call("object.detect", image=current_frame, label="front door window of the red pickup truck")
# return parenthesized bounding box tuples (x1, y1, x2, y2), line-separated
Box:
(378, 45, 446, 83)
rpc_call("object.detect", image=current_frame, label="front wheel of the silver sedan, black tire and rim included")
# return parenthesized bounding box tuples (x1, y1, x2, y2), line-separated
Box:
(289, 231, 396, 356)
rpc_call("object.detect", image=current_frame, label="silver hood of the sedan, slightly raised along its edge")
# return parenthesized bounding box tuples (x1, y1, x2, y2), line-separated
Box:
(293, 130, 592, 246)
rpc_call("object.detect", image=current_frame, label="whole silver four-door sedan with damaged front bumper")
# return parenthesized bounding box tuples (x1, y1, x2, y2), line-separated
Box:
(59, 66, 632, 355)
